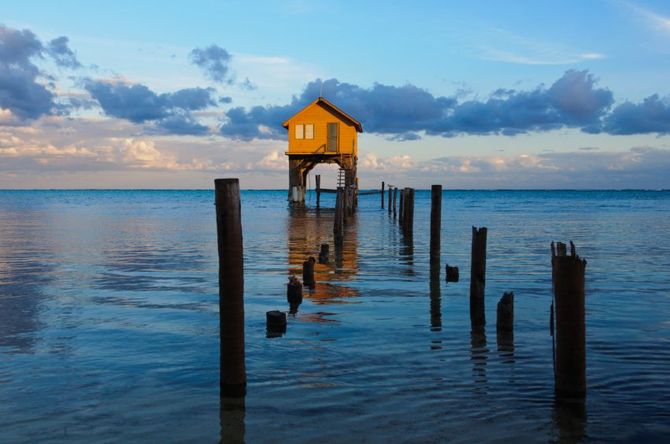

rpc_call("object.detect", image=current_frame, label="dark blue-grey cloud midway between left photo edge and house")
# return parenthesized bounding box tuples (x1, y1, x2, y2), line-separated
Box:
(85, 79, 216, 135)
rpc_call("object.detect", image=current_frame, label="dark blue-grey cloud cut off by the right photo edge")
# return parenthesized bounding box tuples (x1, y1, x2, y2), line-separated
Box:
(603, 94, 670, 134)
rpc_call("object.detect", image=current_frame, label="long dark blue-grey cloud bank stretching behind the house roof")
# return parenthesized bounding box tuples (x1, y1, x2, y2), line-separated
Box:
(221, 71, 613, 140)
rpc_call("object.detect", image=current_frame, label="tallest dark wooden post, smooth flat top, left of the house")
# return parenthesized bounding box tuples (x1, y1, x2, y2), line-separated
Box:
(214, 179, 247, 398)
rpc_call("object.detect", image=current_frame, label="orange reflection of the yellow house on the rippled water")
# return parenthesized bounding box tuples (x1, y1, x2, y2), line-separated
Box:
(286, 208, 358, 304)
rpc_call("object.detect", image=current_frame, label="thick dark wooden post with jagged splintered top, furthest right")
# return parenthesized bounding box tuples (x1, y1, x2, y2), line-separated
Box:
(551, 242, 586, 398)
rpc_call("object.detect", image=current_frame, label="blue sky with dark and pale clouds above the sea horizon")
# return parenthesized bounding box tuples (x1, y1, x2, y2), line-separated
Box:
(0, 0, 670, 189)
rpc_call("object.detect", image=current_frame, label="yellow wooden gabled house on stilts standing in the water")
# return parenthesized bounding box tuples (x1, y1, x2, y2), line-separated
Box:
(283, 97, 363, 203)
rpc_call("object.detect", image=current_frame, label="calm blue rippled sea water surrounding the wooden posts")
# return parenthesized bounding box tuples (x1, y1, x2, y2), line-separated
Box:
(0, 191, 670, 443)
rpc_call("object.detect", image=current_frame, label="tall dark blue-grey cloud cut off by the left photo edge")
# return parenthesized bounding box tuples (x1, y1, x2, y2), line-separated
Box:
(0, 25, 55, 120)
